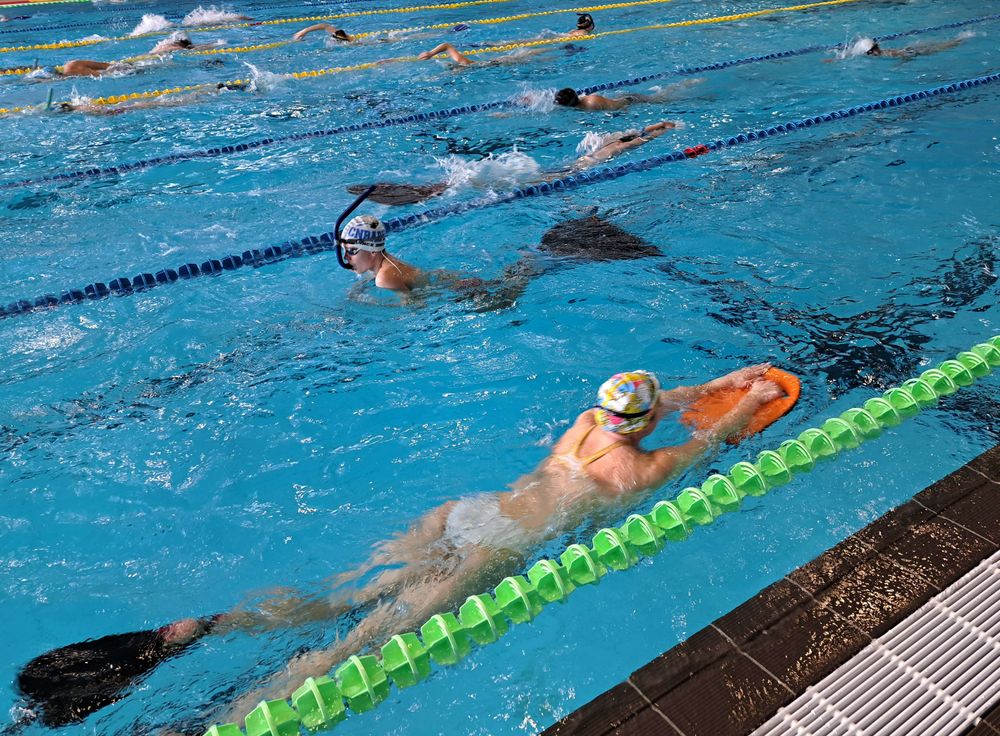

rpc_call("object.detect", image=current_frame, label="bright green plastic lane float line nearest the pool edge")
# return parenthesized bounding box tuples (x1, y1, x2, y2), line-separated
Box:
(205, 336, 1000, 736)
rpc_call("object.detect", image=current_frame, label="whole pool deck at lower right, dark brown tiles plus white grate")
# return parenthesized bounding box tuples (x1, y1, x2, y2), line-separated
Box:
(544, 445, 1000, 736)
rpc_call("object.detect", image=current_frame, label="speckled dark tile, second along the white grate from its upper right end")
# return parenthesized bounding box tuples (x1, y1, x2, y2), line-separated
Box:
(815, 555, 938, 639)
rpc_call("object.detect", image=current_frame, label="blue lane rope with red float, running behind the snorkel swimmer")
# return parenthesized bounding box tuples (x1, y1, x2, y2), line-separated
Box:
(0, 74, 1000, 318)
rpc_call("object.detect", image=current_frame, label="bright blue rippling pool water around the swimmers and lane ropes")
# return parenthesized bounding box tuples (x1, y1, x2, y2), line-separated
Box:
(0, 2, 998, 734)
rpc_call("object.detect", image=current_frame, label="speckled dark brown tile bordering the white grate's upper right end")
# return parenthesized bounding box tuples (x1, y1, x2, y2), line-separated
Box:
(880, 516, 1000, 590)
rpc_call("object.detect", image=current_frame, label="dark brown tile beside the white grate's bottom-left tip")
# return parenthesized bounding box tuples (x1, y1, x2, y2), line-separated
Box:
(656, 653, 795, 736)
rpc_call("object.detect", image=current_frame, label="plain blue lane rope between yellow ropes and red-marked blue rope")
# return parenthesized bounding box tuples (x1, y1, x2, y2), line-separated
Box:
(0, 13, 1000, 191)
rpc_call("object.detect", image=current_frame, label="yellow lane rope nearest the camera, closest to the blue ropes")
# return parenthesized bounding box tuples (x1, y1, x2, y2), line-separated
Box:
(0, 0, 861, 114)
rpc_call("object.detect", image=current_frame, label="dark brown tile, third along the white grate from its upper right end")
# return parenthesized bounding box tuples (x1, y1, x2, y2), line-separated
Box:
(740, 601, 871, 692)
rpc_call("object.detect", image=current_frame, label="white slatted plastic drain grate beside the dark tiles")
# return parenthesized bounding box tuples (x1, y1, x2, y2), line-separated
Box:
(753, 552, 1000, 736)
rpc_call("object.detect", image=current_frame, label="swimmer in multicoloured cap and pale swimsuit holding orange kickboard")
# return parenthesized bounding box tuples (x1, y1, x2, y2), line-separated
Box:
(211, 363, 781, 720)
